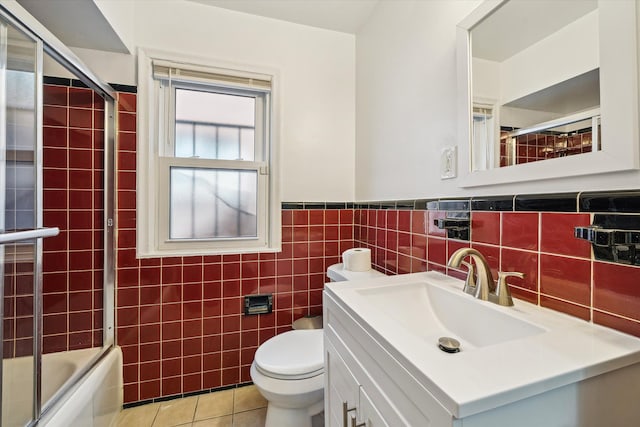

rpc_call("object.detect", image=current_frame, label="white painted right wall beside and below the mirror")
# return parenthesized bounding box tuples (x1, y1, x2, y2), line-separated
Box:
(356, 0, 640, 201)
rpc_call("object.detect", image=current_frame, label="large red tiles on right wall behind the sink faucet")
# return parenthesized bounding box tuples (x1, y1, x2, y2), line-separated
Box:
(354, 209, 640, 337)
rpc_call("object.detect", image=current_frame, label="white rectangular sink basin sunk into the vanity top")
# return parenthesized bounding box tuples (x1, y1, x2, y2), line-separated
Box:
(355, 281, 545, 351)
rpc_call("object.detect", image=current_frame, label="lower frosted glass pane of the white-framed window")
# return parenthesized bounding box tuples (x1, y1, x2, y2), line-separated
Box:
(169, 167, 258, 239)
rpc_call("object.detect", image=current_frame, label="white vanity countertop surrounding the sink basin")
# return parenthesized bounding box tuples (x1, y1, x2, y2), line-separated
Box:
(325, 272, 640, 418)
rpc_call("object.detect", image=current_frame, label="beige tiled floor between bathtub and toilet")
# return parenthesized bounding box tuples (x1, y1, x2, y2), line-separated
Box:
(115, 385, 267, 427)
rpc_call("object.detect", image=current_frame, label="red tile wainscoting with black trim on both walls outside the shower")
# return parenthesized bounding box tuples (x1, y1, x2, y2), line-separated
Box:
(110, 88, 640, 405)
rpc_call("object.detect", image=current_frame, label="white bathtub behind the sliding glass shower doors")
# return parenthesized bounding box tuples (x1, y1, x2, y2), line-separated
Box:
(2, 347, 122, 427)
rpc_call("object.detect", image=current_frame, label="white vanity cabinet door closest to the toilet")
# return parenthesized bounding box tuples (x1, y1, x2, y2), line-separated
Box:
(325, 340, 360, 427)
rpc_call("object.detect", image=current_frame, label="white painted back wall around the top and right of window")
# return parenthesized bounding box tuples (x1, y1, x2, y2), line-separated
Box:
(68, 0, 355, 201)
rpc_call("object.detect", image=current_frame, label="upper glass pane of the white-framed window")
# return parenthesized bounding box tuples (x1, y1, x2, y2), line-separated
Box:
(175, 89, 256, 161)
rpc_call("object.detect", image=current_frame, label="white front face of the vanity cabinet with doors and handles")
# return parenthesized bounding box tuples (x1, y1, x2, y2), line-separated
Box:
(324, 294, 452, 427)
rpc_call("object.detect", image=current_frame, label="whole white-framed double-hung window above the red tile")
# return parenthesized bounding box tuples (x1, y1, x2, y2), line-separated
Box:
(137, 51, 280, 256)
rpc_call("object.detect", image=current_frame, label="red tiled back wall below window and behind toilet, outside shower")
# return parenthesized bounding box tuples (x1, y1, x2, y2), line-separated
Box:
(116, 93, 354, 403)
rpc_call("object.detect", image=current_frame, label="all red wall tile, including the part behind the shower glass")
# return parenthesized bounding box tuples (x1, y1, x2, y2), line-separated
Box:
(10, 85, 640, 403)
